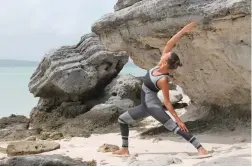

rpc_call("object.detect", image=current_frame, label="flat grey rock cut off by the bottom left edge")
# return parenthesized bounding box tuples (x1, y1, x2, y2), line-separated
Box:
(0, 155, 96, 166)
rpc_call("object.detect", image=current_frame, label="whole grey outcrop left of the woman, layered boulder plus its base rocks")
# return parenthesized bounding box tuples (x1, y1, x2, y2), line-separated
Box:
(29, 33, 141, 137)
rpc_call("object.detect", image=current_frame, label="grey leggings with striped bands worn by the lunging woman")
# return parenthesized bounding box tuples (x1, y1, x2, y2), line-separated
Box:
(118, 84, 201, 149)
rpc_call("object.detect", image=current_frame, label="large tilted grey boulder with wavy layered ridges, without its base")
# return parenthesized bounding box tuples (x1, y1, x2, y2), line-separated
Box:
(29, 33, 128, 98)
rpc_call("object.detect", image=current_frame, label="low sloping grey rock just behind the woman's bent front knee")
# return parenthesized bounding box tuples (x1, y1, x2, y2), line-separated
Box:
(59, 99, 134, 137)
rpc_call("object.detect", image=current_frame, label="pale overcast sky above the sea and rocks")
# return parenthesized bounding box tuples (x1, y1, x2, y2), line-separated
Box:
(0, 0, 117, 61)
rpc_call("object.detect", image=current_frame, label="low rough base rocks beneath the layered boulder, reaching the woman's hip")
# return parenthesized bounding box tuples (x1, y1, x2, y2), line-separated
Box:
(30, 75, 142, 136)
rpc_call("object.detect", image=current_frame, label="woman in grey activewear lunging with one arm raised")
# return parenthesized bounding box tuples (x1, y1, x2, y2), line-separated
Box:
(113, 22, 208, 156)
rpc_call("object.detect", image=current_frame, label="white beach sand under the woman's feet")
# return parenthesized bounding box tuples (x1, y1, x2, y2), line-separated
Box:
(0, 127, 251, 166)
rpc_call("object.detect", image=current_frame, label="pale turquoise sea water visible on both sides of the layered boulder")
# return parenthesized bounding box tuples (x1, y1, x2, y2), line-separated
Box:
(0, 64, 145, 117)
